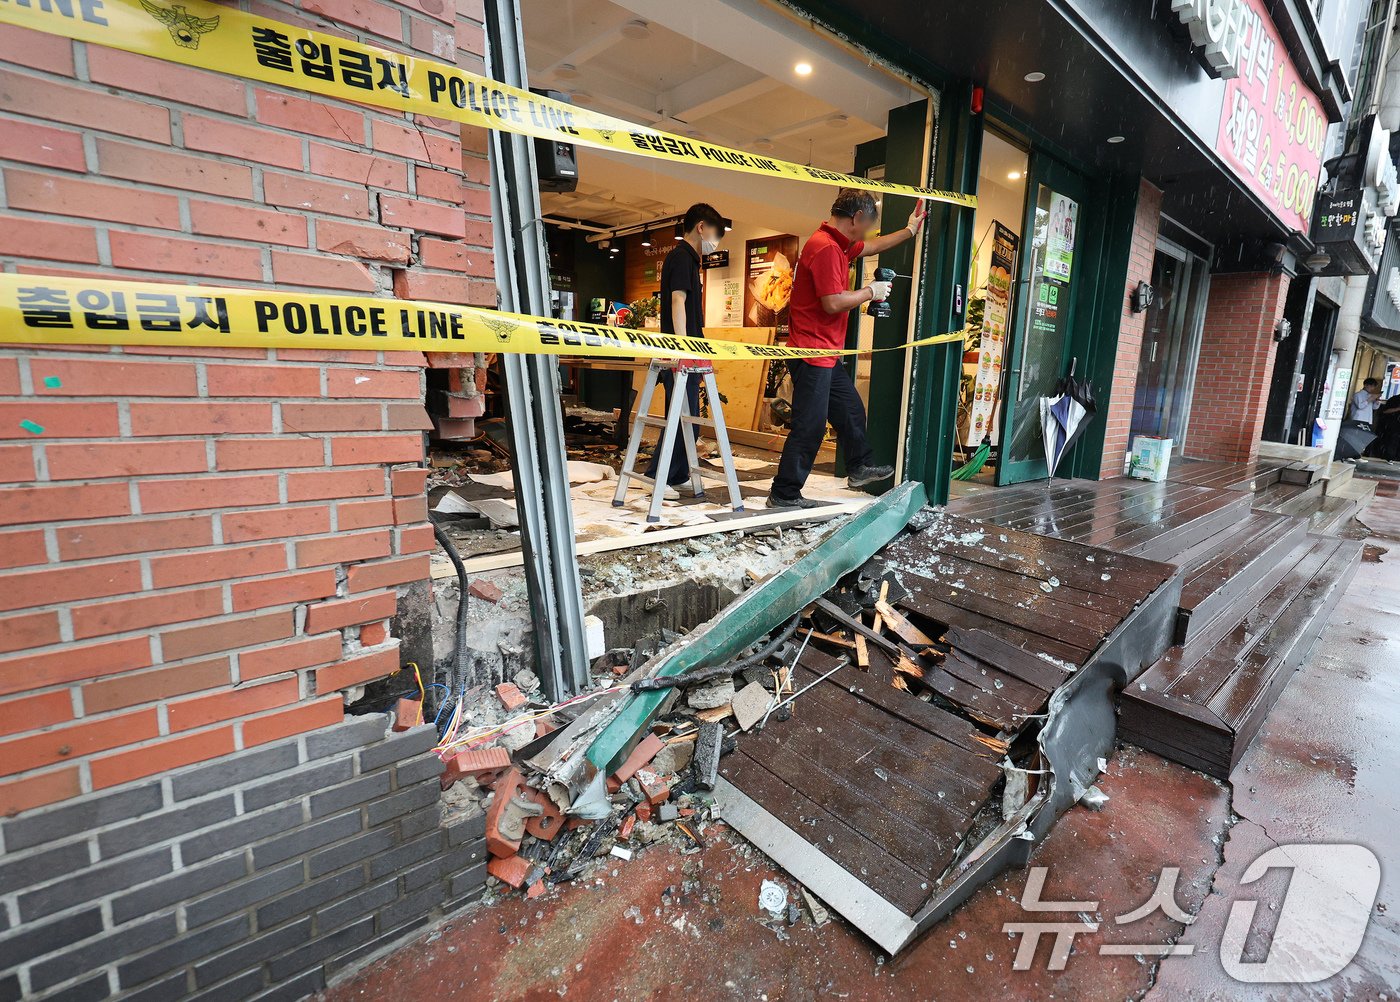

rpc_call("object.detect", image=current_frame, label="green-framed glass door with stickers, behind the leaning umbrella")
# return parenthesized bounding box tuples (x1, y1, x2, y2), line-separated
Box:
(997, 155, 1088, 484)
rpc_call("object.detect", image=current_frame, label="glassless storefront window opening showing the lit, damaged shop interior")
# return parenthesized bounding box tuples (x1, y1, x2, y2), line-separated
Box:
(434, 0, 937, 556)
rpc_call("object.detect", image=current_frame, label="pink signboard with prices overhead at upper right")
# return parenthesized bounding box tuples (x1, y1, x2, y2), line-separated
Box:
(1215, 0, 1327, 232)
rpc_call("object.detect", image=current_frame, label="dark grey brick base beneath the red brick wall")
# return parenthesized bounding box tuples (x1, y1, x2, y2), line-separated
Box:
(0, 714, 486, 1002)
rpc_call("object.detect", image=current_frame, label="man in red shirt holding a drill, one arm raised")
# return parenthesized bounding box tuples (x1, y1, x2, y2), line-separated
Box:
(769, 188, 924, 508)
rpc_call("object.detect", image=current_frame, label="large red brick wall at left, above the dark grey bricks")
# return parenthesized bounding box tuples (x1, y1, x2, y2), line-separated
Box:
(0, 0, 494, 813)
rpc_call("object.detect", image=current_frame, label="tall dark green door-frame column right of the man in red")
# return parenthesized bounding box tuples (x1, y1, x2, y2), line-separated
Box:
(904, 81, 983, 504)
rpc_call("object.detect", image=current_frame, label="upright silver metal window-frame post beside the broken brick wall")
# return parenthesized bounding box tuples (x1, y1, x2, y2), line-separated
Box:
(484, 0, 588, 700)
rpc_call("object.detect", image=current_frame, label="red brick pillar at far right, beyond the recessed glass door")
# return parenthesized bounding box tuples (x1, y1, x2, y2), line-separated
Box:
(1184, 271, 1288, 463)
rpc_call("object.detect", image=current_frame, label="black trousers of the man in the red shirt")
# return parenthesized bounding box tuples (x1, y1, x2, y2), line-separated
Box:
(773, 358, 871, 501)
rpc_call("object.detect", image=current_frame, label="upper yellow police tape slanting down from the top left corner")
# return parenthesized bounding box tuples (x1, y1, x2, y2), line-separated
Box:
(0, 0, 977, 206)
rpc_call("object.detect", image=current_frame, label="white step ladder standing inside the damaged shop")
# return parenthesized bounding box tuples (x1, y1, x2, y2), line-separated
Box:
(613, 358, 743, 522)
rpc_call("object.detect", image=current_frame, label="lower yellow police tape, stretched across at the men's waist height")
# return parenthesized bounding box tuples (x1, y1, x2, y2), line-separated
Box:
(0, 274, 966, 361)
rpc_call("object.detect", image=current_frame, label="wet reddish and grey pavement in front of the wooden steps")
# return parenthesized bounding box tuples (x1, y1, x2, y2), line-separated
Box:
(325, 498, 1400, 1002)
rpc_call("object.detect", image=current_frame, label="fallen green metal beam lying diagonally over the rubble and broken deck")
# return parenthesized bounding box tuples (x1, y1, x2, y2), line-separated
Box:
(588, 483, 928, 775)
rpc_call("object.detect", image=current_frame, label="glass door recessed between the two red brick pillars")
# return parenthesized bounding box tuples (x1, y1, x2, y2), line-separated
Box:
(1131, 241, 1210, 452)
